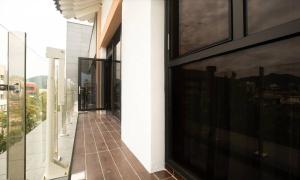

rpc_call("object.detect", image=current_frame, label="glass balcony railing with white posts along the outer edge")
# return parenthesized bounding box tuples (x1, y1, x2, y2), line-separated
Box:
(0, 25, 77, 180)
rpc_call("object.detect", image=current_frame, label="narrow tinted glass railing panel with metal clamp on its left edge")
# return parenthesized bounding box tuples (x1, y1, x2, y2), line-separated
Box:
(8, 32, 26, 179)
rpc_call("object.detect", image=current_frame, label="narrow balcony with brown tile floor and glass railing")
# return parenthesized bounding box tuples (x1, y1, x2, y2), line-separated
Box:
(0, 22, 176, 180)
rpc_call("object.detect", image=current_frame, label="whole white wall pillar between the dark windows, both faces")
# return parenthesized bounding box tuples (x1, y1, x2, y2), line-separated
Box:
(122, 0, 165, 172)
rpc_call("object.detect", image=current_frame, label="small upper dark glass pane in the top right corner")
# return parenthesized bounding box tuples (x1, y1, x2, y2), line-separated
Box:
(247, 0, 300, 33)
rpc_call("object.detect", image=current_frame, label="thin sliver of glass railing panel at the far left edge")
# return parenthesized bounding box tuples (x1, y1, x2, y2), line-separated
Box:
(0, 26, 8, 180)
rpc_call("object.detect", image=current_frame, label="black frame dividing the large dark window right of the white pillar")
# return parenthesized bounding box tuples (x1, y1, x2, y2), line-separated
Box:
(165, 0, 300, 179)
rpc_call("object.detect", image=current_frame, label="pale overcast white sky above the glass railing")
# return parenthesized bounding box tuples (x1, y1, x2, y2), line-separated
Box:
(0, 0, 91, 77)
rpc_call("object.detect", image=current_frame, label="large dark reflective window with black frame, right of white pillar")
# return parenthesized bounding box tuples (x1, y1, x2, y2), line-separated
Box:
(166, 0, 300, 180)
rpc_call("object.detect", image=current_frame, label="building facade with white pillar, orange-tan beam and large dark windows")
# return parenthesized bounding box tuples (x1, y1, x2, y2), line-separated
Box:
(54, 0, 300, 180)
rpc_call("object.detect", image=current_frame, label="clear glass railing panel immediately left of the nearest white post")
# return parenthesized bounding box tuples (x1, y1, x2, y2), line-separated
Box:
(26, 46, 48, 179)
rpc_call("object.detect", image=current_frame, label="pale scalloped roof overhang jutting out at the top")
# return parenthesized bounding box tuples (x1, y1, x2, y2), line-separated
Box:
(53, 0, 102, 22)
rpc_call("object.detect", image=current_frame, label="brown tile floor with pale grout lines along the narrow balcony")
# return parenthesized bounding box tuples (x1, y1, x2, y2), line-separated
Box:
(71, 112, 176, 180)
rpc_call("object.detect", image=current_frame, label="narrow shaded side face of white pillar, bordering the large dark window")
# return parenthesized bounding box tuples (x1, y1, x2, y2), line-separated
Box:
(150, 0, 165, 171)
